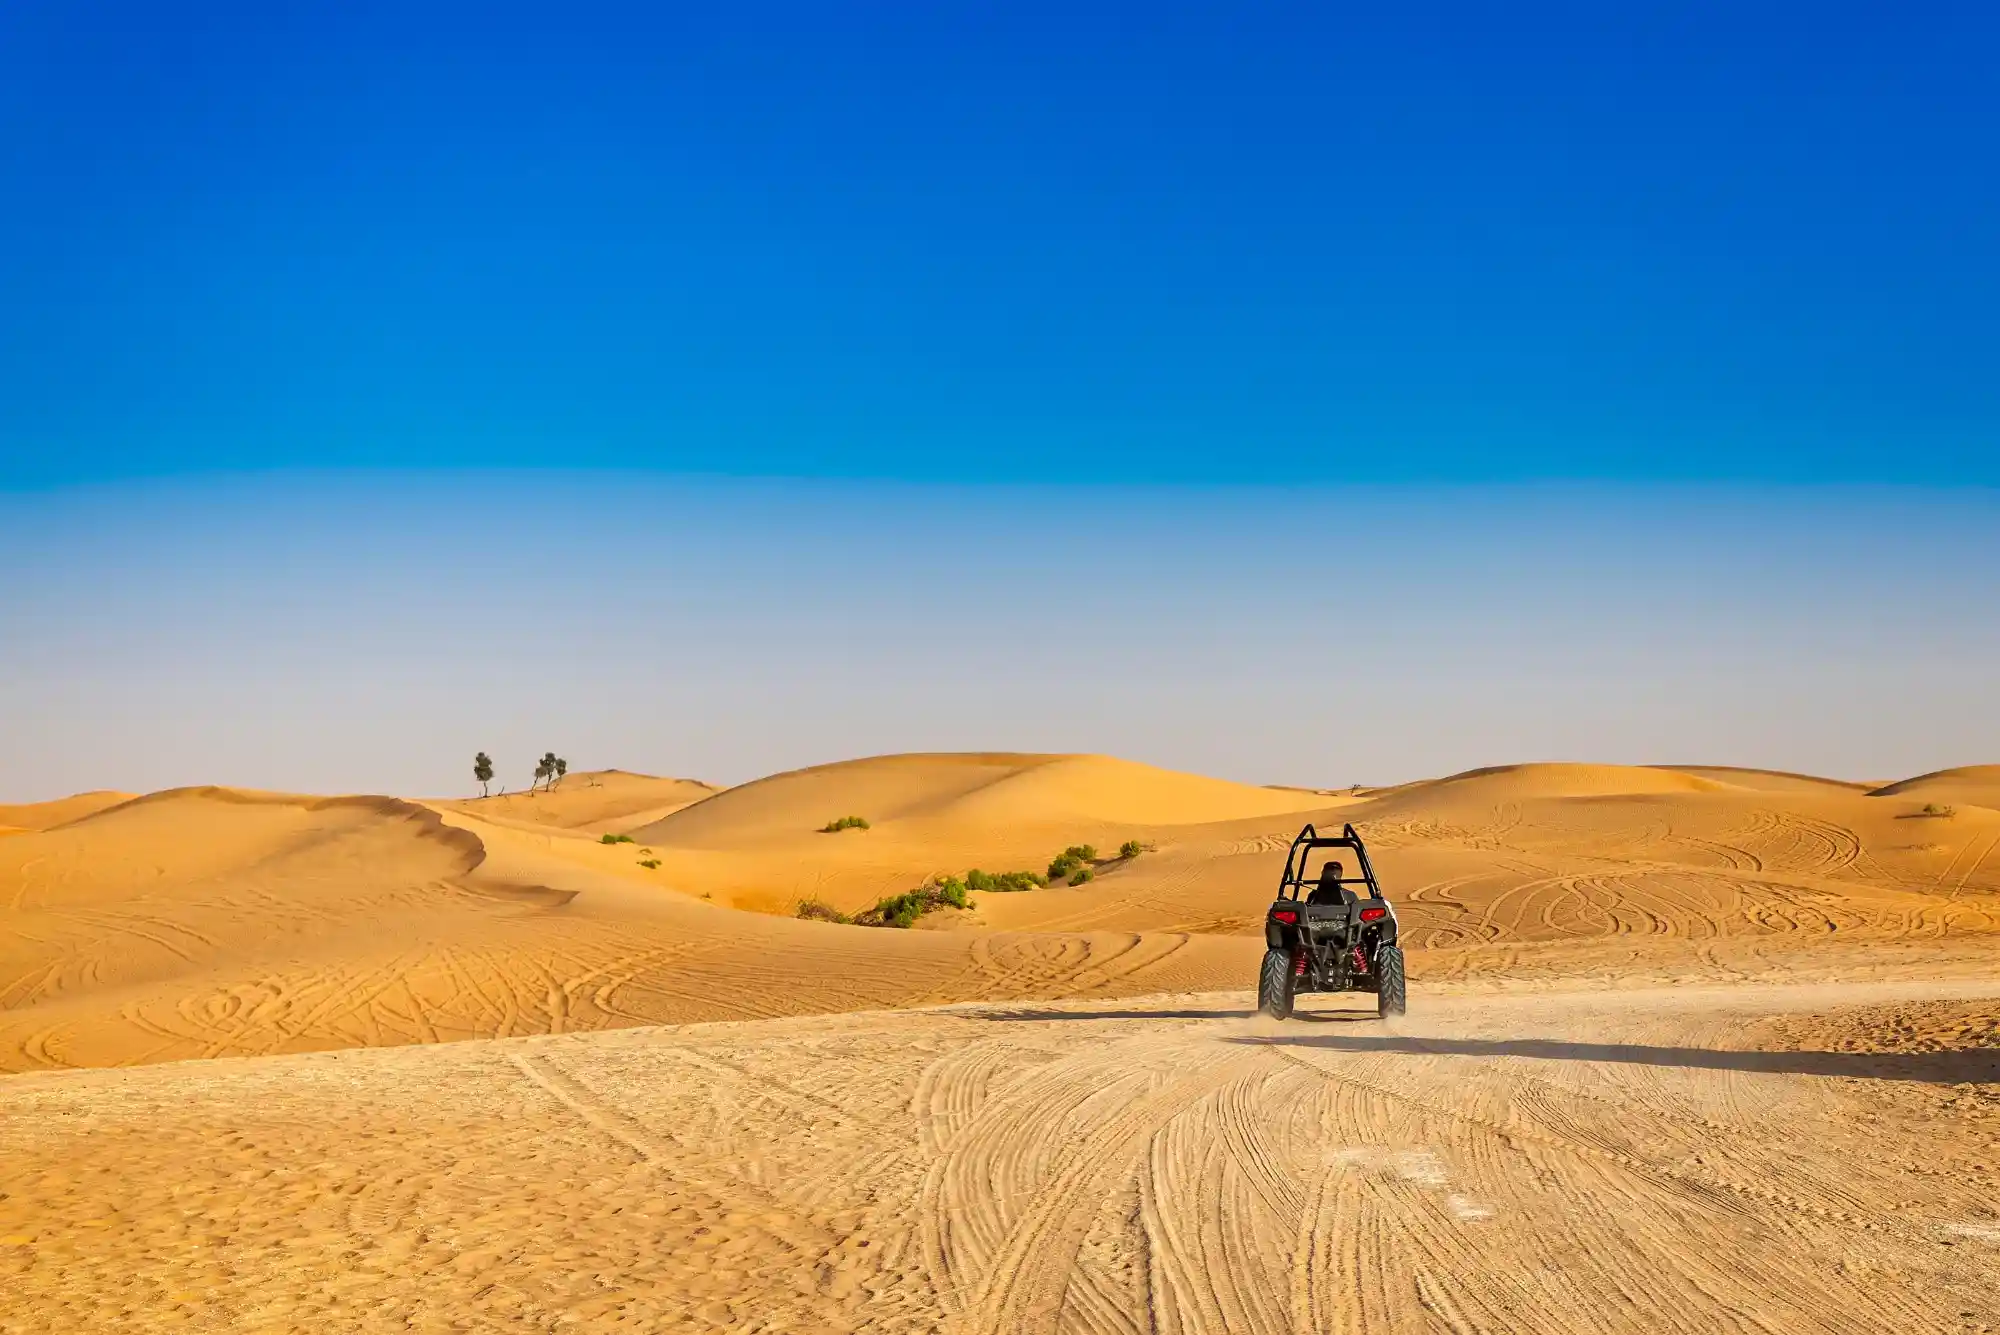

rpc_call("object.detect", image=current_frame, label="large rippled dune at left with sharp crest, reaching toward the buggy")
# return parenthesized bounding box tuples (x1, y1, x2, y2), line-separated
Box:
(0, 789, 1254, 1069)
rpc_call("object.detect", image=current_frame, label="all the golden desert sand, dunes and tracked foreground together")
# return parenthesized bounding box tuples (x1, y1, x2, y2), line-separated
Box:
(0, 755, 2000, 1331)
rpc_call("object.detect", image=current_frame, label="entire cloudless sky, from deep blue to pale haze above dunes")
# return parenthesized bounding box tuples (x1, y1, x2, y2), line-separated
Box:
(0, 0, 2000, 799)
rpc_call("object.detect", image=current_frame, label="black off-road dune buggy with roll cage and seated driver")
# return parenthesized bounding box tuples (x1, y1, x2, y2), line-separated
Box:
(1256, 825, 1406, 1019)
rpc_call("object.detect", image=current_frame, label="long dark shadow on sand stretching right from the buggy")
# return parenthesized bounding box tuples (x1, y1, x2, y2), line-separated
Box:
(1226, 1033, 2000, 1085)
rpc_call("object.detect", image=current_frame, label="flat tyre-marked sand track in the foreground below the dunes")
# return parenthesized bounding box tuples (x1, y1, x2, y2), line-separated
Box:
(0, 981, 2000, 1335)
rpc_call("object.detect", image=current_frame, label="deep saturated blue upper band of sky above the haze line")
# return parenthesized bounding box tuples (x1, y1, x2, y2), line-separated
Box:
(0, 0, 2000, 490)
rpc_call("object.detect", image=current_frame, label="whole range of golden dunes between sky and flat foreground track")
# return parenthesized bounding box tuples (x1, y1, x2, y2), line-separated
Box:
(0, 755, 2000, 1069)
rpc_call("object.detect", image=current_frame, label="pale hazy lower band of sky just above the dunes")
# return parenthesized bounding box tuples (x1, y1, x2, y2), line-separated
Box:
(0, 474, 2000, 801)
